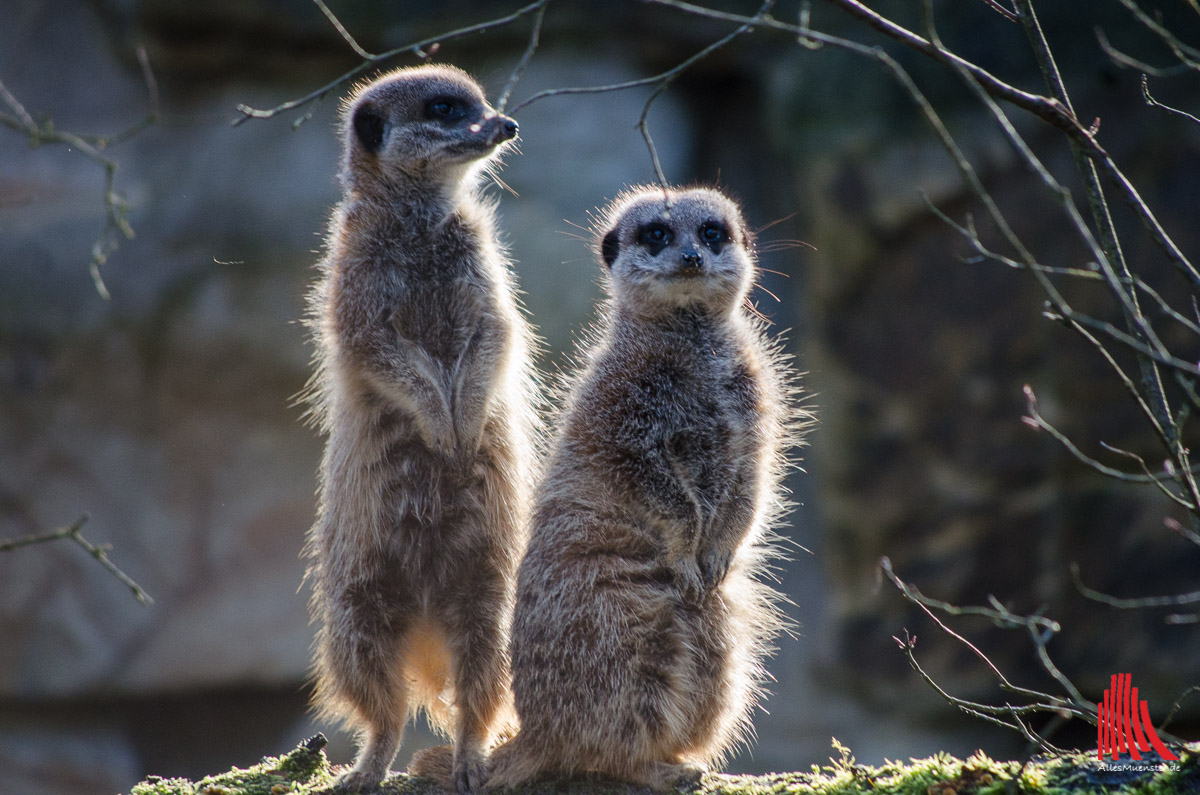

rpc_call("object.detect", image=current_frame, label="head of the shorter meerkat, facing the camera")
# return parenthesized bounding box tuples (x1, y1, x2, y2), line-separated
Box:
(599, 187, 755, 313)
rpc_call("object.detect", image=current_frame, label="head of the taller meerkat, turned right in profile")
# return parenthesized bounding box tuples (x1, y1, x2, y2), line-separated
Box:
(342, 66, 517, 198)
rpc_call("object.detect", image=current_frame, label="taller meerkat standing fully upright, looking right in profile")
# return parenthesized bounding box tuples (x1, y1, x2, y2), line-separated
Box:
(307, 66, 535, 791)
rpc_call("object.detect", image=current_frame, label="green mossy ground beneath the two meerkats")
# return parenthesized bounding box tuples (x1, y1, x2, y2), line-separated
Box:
(130, 735, 1200, 795)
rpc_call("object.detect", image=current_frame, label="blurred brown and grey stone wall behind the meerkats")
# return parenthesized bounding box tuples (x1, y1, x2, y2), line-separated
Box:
(0, 0, 1200, 794)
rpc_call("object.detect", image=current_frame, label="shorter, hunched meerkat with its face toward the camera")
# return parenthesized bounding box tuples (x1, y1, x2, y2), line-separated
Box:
(488, 187, 803, 789)
